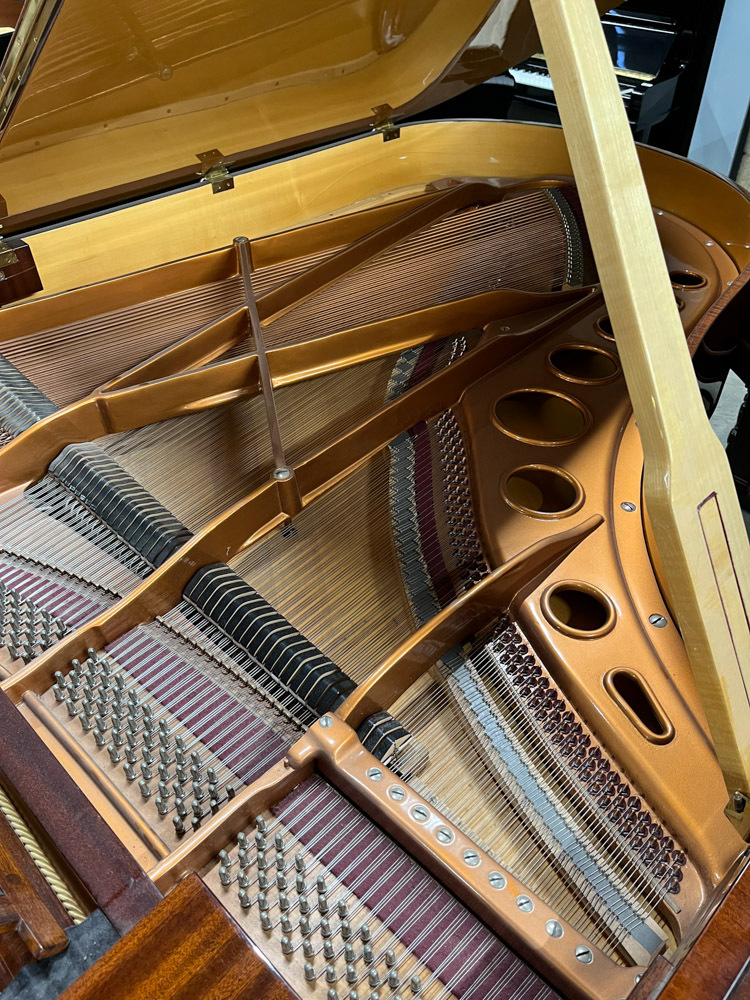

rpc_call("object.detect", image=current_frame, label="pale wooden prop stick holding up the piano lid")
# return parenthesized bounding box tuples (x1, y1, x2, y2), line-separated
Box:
(530, 0, 750, 793)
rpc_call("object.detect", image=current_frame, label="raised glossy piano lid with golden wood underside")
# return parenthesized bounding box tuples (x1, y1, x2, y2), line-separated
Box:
(0, 0, 612, 232)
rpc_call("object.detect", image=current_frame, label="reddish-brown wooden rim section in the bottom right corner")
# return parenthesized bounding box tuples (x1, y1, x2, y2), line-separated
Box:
(630, 867, 750, 1000)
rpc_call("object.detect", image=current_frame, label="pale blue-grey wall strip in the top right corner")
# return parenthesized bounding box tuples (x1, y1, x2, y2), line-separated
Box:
(688, 0, 750, 174)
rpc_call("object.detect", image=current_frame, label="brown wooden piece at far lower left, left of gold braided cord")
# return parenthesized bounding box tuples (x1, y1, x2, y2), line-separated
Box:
(0, 813, 72, 989)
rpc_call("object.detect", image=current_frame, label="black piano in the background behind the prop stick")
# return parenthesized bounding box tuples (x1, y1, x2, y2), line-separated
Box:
(410, 0, 724, 156)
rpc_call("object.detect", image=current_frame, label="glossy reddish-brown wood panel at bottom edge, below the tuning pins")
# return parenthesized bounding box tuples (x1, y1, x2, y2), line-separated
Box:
(60, 874, 294, 1000)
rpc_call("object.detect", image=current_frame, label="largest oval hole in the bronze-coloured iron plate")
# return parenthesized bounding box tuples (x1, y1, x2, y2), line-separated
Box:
(495, 389, 591, 445)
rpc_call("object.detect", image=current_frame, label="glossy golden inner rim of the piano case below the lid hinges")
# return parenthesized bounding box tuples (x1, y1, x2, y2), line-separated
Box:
(11, 121, 750, 296)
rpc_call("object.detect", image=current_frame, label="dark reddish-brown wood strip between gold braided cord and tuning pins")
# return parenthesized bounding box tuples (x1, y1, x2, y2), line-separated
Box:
(0, 693, 161, 934)
